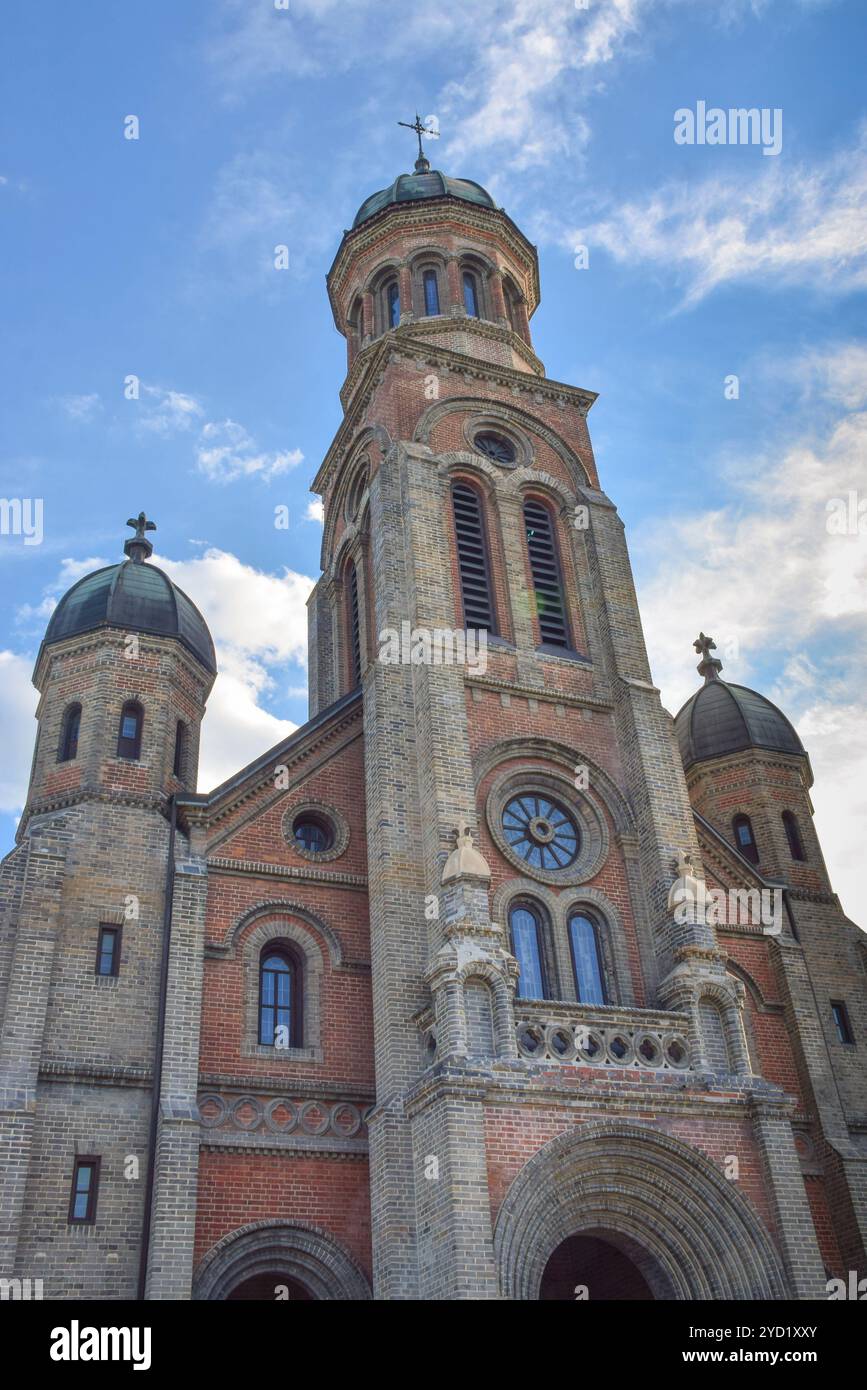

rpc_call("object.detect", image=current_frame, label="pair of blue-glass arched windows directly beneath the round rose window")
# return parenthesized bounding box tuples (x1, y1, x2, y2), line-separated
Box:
(509, 901, 609, 1004)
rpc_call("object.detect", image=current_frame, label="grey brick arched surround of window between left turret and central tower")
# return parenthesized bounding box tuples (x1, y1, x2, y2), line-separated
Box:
(240, 916, 324, 1066)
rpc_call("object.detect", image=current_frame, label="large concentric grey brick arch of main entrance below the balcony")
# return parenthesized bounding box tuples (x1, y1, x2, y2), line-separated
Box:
(495, 1120, 788, 1301)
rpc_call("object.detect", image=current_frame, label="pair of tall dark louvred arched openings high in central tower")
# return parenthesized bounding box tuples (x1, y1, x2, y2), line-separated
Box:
(452, 481, 572, 651)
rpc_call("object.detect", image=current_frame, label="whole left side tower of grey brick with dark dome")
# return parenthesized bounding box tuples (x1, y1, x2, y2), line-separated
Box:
(0, 514, 215, 1298)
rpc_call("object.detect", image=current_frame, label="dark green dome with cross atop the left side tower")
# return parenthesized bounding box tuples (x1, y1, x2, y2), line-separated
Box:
(43, 513, 217, 671)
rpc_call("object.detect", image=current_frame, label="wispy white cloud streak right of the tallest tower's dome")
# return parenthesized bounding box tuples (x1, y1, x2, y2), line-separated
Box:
(564, 131, 867, 304)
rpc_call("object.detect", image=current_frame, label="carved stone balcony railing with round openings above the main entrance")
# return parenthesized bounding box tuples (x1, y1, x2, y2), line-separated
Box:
(514, 999, 691, 1072)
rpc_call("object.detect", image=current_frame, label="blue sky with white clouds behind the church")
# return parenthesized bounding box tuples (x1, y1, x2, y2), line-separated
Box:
(0, 0, 867, 917)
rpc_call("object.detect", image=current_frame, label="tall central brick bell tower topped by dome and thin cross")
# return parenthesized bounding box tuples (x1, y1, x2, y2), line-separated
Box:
(304, 120, 828, 1300)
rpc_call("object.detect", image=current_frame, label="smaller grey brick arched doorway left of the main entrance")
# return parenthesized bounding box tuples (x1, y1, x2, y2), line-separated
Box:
(193, 1220, 371, 1302)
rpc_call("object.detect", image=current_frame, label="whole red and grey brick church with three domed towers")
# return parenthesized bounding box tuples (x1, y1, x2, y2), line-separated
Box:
(0, 131, 867, 1301)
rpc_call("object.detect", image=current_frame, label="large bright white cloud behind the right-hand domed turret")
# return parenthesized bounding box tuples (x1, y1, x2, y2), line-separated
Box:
(634, 337, 867, 923)
